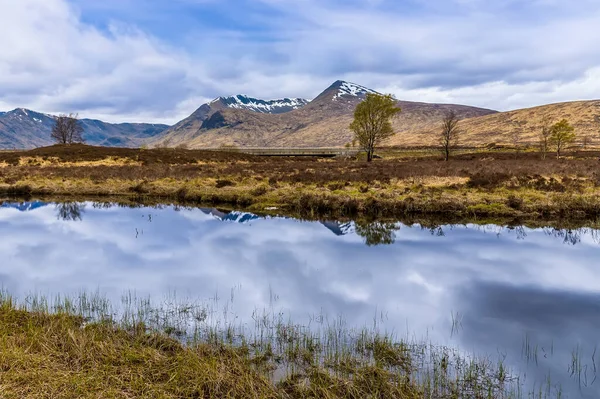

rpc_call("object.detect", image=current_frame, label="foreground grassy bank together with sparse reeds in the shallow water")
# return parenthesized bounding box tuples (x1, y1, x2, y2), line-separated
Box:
(0, 295, 560, 399)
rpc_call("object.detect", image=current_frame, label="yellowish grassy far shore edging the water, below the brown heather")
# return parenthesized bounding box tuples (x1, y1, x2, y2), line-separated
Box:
(0, 178, 600, 220)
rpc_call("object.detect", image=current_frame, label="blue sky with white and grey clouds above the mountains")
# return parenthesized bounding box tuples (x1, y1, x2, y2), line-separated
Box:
(0, 0, 600, 123)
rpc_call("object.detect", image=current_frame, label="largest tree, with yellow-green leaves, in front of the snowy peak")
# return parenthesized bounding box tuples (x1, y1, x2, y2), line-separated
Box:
(350, 93, 401, 162)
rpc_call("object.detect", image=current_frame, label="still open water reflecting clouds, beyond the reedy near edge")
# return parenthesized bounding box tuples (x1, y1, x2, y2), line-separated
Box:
(0, 202, 600, 398)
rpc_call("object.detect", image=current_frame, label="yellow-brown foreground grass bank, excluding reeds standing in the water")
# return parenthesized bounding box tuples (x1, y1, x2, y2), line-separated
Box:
(0, 302, 423, 399)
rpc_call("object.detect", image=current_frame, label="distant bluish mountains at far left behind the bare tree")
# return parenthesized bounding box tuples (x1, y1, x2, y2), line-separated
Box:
(0, 108, 168, 149)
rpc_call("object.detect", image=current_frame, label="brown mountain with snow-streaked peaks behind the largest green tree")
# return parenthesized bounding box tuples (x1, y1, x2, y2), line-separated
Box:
(151, 80, 496, 148)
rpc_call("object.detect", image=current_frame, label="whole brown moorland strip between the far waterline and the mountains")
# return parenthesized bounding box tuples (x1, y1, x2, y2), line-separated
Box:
(0, 145, 600, 218)
